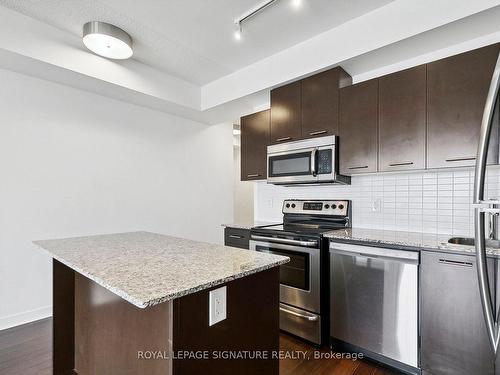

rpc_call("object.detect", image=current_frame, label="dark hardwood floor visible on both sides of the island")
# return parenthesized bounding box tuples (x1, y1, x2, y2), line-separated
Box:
(0, 319, 396, 375)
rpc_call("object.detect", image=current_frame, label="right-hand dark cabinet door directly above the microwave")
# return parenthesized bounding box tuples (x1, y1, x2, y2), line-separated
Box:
(302, 67, 352, 138)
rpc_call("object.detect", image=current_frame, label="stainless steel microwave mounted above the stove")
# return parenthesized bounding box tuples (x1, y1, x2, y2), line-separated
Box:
(267, 135, 351, 185)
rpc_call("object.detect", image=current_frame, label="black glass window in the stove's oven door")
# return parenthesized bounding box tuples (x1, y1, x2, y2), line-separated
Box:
(256, 246, 310, 290)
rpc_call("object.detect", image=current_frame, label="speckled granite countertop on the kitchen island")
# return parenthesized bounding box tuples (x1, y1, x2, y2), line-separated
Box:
(34, 232, 289, 308)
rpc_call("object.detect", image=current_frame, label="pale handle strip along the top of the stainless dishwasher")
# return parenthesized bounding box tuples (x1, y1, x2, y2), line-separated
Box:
(330, 242, 419, 264)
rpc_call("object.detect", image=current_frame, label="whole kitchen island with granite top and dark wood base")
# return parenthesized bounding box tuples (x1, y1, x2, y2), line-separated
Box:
(35, 232, 289, 375)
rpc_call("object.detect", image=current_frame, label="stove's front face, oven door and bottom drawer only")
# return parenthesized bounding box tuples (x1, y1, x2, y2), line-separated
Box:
(250, 235, 321, 344)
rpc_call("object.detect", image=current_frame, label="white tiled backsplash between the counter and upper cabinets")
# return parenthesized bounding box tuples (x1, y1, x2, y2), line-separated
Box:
(255, 167, 500, 236)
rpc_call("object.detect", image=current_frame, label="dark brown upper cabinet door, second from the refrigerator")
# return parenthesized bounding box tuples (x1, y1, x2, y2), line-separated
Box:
(379, 65, 426, 171)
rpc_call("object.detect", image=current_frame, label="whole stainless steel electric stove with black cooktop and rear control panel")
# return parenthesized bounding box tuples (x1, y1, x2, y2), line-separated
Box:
(249, 199, 352, 345)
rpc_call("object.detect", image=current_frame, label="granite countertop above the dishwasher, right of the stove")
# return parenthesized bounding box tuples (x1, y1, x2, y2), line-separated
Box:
(325, 228, 500, 256)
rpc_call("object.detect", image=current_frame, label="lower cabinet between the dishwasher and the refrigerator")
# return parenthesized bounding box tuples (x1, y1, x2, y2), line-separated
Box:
(420, 251, 495, 375)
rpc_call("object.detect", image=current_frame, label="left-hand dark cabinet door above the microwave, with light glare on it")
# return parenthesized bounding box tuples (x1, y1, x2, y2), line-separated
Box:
(271, 81, 301, 143)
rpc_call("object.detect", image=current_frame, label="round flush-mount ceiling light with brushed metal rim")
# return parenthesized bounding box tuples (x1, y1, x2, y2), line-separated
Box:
(83, 21, 133, 60)
